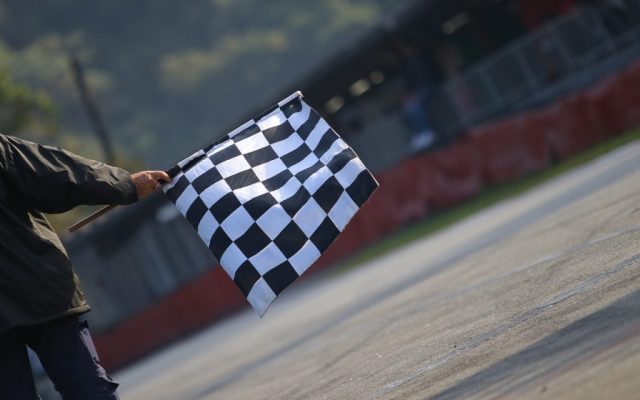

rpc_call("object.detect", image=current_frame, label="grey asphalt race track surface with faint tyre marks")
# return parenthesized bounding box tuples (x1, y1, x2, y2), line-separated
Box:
(116, 142, 640, 400)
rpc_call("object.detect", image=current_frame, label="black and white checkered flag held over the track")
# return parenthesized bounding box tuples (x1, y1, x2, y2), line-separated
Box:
(164, 92, 378, 316)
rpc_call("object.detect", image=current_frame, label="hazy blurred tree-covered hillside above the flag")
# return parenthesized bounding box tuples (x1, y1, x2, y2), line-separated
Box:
(0, 0, 404, 168)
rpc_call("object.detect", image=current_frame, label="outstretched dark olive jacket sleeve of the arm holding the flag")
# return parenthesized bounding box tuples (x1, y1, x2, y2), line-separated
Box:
(0, 135, 138, 213)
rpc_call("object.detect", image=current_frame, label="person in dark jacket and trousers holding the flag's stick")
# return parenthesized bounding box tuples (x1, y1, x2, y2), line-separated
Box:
(0, 134, 170, 400)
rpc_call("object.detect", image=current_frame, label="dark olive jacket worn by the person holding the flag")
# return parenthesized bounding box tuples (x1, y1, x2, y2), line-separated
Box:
(0, 134, 137, 334)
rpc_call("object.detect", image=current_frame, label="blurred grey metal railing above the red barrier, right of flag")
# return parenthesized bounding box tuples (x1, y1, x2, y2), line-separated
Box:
(350, 5, 640, 170)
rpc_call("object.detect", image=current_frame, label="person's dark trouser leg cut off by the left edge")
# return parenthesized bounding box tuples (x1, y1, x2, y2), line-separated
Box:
(0, 329, 38, 400)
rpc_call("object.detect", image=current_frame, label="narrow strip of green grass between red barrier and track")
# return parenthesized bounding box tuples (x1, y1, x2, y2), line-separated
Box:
(334, 129, 640, 273)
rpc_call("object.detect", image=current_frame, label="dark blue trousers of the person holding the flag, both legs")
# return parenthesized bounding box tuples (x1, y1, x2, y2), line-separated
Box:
(0, 316, 118, 400)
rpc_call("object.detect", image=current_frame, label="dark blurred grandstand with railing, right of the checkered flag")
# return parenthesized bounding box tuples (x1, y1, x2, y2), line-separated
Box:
(301, 1, 640, 170)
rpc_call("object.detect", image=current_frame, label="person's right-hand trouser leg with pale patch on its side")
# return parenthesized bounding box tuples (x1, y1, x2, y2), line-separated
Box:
(26, 317, 118, 400)
